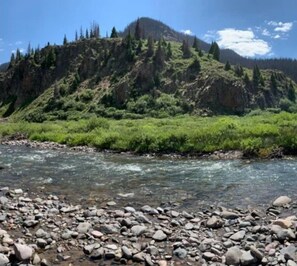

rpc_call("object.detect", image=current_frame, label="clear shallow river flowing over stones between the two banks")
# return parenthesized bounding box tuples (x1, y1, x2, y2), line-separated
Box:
(0, 145, 297, 211)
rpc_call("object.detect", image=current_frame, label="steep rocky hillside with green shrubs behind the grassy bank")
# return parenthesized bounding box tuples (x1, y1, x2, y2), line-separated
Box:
(0, 30, 296, 122)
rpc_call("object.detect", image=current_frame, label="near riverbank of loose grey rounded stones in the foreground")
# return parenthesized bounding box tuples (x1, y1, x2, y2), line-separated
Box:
(0, 188, 297, 266)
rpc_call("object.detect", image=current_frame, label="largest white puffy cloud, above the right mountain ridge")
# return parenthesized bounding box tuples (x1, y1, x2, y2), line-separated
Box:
(217, 28, 271, 57)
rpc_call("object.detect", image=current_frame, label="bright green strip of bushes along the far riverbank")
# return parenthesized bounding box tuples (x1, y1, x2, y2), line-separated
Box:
(0, 112, 297, 157)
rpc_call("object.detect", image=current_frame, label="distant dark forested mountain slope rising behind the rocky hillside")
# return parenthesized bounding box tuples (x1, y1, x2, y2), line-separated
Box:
(121, 17, 297, 82)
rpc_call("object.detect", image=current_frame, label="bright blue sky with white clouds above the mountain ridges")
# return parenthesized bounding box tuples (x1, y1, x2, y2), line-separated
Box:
(0, 0, 297, 64)
